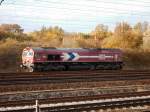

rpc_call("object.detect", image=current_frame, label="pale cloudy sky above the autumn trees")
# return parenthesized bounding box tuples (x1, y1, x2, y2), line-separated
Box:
(0, 0, 150, 32)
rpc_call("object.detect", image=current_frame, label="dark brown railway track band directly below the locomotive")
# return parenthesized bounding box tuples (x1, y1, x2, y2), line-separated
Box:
(0, 70, 150, 86)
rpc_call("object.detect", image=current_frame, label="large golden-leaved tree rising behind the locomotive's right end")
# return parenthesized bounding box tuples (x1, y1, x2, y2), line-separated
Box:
(103, 22, 142, 49)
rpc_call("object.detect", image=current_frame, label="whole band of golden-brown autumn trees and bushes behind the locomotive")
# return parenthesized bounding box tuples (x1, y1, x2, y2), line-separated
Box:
(0, 22, 150, 72)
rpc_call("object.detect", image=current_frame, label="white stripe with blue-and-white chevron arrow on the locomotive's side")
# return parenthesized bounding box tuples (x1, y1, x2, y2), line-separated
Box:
(61, 52, 113, 61)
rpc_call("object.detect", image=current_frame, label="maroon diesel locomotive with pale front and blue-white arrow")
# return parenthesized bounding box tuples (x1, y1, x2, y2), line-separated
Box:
(22, 47, 123, 72)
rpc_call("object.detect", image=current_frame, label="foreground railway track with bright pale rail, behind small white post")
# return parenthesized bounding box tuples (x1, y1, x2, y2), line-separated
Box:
(0, 92, 150, 112)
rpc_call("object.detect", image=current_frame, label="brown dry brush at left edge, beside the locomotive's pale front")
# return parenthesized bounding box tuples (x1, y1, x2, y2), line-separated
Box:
(0, 39, 30, 72)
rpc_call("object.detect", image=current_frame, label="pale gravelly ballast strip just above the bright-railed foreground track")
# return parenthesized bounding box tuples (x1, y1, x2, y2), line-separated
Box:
(0, 85, 150, 102)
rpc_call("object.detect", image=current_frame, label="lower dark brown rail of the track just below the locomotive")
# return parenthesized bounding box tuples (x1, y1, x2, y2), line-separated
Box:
(0, 75, 150, 86)
